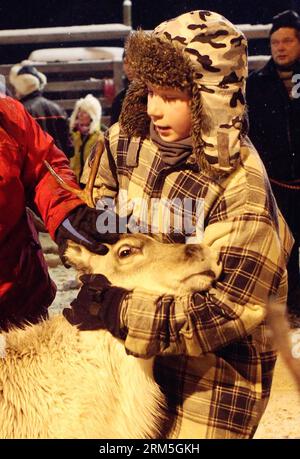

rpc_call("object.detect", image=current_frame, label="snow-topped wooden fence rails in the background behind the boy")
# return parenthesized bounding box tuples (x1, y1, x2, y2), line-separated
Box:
(0, 24, 270, 125)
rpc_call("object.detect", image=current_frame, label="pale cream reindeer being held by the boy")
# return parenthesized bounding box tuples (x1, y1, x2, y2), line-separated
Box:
(0, 234, 221, 439)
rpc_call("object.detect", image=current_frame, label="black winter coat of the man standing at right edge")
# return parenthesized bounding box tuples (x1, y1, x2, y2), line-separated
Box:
(246, 59, 300, 184)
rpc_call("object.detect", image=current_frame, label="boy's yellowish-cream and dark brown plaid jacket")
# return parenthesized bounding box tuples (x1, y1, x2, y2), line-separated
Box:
(85, 125, 292, 438)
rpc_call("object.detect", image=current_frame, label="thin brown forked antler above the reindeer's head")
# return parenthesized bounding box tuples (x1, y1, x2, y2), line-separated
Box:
(44, 135, 104, 207)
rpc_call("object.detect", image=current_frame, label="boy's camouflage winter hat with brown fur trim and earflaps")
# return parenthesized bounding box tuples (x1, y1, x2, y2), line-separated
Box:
(120, 11, 247, 175)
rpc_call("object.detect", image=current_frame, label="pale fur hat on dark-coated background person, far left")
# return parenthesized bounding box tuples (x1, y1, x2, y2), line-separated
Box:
(9, 61, 47, 97)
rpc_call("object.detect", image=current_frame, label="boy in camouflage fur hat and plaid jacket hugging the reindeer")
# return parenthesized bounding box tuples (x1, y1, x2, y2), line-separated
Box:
(64, 11, 291, 438)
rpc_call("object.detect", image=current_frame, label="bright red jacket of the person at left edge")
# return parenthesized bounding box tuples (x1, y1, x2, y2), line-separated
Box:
(0, 96, 82, 329)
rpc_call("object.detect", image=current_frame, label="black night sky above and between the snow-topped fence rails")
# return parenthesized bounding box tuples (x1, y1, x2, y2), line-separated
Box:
(0, 0, 300, 63)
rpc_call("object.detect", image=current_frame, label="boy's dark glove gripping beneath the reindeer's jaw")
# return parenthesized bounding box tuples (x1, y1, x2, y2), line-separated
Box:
(63, 274, 129, 337)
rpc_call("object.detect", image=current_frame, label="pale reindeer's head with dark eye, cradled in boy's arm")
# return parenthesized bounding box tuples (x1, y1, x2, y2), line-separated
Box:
(65, 234, 221, 295)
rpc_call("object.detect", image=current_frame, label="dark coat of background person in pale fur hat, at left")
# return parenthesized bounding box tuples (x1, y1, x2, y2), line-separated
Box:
(21, 91, 72, 157)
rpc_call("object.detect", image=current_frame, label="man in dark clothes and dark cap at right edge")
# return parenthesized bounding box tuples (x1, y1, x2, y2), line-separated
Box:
(246, 10, 300, 316)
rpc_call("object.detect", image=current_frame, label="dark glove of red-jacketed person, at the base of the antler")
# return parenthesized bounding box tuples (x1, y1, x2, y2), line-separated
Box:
(55, 205, 127, 267)
